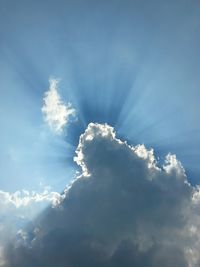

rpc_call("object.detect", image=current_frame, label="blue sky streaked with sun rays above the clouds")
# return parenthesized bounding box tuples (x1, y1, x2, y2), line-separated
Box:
(0, 0, 200, 191)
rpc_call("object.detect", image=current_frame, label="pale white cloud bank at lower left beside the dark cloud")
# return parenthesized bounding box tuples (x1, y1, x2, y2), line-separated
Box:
(0, 187, 63, 266)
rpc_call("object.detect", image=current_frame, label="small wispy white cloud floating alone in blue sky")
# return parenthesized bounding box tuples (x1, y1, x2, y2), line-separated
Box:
(42, 79, 76, 133)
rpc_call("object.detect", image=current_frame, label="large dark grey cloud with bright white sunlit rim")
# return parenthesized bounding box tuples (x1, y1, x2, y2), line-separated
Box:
(4, 123, 200, 267)
